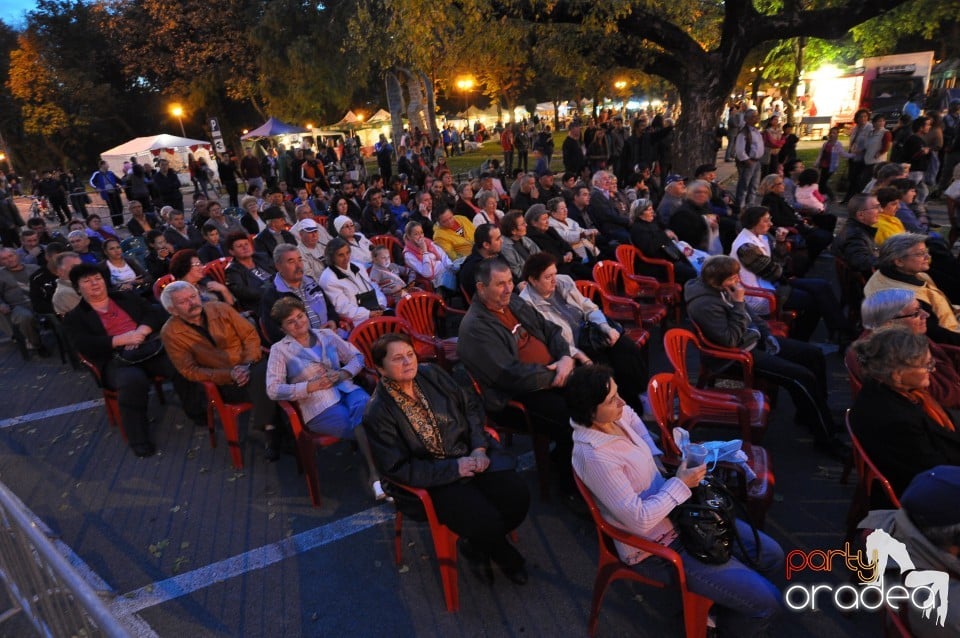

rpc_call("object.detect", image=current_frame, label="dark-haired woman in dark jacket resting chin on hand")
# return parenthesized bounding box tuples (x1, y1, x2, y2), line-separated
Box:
(683, 255, 849, 459)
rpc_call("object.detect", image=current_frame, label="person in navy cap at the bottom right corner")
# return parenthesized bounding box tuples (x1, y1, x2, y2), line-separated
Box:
(859, 465, 960, 638)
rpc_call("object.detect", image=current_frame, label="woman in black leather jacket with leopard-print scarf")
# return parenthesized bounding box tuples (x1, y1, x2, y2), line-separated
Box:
(363, 333, 530, 585)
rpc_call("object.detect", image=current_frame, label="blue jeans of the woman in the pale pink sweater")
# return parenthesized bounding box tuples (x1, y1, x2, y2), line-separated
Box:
(635, 520, 783, 638)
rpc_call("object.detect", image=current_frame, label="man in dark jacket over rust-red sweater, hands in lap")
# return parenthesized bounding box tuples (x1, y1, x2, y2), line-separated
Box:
(457, 259, 574, 491)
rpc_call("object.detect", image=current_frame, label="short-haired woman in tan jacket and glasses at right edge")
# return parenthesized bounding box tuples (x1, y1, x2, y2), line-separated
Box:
(863, 233, 960, 346)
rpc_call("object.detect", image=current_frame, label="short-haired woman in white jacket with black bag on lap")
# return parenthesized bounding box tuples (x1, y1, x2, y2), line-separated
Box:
(319, 237, 387, 325)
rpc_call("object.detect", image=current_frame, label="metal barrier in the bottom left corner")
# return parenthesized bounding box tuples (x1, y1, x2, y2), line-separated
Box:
(0, 483, 130, 638)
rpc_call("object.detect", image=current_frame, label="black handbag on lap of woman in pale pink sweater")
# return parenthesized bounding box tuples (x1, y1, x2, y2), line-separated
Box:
(670, 475, 760, 567)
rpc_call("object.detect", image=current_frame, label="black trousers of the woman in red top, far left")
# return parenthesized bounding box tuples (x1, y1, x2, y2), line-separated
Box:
(103, 352, 203, 446)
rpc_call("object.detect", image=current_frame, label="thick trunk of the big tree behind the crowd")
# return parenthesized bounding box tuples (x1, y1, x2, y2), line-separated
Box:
(673, 80, 730, 180)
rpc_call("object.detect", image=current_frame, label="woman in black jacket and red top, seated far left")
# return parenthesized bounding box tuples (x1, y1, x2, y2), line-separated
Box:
(63, 264, 206, 456)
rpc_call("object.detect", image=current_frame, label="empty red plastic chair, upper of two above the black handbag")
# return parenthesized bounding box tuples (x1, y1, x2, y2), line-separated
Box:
(663, 328, 770, 448)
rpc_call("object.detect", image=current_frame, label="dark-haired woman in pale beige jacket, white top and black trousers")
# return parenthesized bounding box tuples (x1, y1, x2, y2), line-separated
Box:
(520, 252, 649, 413)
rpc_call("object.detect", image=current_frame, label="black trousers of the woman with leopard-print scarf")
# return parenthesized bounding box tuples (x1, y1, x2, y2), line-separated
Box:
(427, 470, 530, 569)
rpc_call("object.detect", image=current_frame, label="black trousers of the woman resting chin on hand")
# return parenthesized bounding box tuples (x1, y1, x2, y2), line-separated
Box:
(751, 339, 835, 441)
